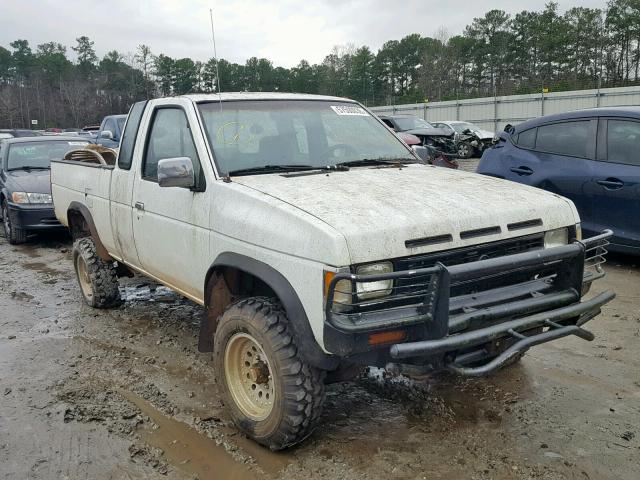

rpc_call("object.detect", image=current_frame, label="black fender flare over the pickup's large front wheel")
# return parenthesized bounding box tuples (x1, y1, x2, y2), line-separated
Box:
(198, 252, 340, 370)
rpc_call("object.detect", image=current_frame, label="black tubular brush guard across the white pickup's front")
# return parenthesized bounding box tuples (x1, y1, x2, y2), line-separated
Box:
(325, 230, 615, 376)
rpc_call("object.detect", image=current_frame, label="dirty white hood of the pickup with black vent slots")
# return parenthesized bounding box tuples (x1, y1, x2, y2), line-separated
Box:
(233, 164, 579, 263)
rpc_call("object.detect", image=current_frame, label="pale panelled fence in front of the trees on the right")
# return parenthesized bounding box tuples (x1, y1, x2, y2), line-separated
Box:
(371, 87, 640, 131)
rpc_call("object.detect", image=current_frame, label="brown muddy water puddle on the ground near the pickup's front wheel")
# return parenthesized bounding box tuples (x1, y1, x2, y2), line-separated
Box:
(119, 390, 262, 480)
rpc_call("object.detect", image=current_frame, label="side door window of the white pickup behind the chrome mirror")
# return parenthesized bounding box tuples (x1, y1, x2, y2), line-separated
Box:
(142, 107, 201, 182)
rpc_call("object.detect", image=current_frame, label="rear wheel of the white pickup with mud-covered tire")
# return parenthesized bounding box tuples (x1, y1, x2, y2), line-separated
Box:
(73, 238, 122, 308)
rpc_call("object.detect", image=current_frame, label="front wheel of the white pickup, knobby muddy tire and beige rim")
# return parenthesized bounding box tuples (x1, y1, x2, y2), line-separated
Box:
(213, 297, 325, 450)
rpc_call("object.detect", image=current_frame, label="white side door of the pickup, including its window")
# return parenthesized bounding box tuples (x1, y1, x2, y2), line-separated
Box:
(132, 100, 213, 301)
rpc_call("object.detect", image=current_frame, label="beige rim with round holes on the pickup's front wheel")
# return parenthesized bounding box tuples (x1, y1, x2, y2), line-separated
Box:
(224, 333, 275, 421)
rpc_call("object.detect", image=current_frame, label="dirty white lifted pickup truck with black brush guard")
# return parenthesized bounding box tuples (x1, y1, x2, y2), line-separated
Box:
(51, 93, 614, 449)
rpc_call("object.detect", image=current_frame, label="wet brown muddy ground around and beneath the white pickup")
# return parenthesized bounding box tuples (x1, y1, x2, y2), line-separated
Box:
(0, 230, 640, 480)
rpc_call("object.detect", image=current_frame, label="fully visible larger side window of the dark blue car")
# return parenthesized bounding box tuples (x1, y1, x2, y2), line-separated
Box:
(535, 120, 591, 158)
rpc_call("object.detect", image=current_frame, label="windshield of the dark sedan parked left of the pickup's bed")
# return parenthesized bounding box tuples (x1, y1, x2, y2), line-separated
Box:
(7, 140, 88, 170)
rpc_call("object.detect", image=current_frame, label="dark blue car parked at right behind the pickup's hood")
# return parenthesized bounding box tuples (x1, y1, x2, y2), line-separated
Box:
(477, 107, 640, 254)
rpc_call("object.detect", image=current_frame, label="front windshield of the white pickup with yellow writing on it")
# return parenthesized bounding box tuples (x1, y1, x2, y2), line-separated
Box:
(198, 100, 416, 175)
